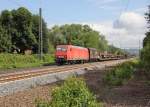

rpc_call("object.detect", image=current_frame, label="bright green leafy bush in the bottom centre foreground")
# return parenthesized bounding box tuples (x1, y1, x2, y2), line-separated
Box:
(37, 78, 102, 107)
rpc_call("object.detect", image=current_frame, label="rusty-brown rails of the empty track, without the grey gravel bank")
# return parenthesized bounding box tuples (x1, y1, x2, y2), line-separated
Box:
(0, 61, 130, 84)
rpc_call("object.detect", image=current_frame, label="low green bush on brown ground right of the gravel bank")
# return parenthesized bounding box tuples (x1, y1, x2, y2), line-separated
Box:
(104, 61, 138, 86)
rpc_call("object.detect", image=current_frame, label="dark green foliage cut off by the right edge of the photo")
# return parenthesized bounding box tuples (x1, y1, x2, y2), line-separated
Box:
(141, 6, 150, 71)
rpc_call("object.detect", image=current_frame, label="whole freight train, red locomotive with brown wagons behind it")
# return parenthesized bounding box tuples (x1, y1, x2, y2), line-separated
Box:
(55, 45, 125, 65)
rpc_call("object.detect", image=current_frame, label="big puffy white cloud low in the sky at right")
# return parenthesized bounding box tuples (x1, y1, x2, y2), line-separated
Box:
(82, 12, 146, 48)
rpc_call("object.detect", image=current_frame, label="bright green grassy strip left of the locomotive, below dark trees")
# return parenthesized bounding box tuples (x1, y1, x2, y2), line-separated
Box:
(0, 53, 54, 69)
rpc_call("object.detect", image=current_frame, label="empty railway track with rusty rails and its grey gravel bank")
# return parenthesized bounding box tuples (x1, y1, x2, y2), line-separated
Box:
(0, 59, 131, 96)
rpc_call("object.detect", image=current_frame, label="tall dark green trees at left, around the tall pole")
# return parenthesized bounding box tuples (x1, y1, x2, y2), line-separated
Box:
(0, 7, 49, 53)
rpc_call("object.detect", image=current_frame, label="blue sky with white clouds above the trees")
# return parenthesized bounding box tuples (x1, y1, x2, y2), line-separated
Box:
(0, 0, 150, 49)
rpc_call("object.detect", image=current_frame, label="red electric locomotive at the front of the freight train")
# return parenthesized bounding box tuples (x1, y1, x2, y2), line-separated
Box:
(55, 45, 89, 64)
